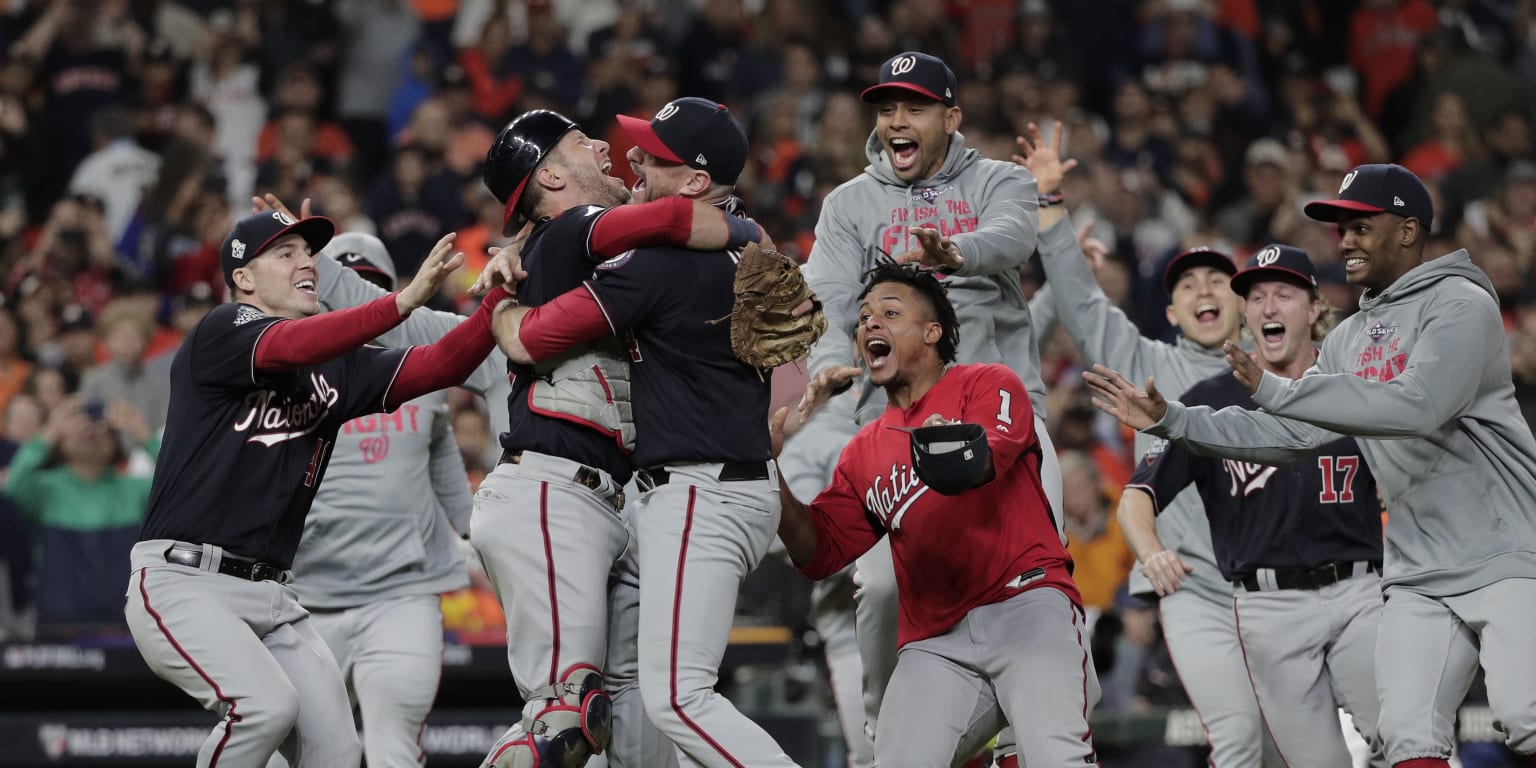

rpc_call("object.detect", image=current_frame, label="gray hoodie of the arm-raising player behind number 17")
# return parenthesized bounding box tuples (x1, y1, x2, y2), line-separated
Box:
(1040, 217, 1232, 601)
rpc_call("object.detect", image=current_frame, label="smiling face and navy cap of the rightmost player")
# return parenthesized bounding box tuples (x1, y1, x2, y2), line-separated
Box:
(1304, 164, 1435, 292)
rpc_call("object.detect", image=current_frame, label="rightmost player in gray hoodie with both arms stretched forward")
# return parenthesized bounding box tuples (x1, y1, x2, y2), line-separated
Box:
(1086, 164, 1536, 768)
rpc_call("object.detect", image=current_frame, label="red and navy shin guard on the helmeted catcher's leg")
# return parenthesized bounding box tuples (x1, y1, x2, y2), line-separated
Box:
(490, 664, 613, 768)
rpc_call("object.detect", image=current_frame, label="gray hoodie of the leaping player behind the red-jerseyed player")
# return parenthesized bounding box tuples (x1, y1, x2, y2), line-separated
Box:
(805, 132, 1046, 421)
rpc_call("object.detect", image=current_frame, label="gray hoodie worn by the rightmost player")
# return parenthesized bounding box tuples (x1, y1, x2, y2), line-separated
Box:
(1147, 250, 1536, 596)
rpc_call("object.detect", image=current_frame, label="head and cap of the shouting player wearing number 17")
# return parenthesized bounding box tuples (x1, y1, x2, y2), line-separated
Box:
(1232, 244, 1322, 378)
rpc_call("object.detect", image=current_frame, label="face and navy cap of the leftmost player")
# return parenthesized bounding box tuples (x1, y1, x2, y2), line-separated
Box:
(220, 210, 336, 318)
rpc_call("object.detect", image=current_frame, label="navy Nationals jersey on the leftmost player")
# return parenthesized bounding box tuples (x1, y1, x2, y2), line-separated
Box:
(140, 303, 406, 568)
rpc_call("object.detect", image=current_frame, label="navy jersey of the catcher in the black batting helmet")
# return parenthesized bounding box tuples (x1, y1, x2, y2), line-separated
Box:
(501, 206, 631, 482)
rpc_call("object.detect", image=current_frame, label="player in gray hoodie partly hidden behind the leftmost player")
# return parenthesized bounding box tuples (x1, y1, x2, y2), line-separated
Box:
(282, 233, 470, 768)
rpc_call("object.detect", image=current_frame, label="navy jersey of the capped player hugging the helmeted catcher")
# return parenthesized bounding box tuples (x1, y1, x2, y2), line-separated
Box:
(587, 247, 771, 467)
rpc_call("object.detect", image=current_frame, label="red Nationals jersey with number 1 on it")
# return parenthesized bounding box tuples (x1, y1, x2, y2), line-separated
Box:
(800, 362, 1081, 645)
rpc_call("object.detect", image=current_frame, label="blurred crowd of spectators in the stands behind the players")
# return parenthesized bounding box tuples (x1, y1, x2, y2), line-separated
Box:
(0, 0, 1536, 761)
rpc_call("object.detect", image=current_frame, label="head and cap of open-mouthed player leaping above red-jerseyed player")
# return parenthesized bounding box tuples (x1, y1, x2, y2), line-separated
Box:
(860, 51, 960, 183)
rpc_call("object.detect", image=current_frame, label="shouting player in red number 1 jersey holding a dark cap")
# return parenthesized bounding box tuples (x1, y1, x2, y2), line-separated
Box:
(774, 264, 1098, 768)
